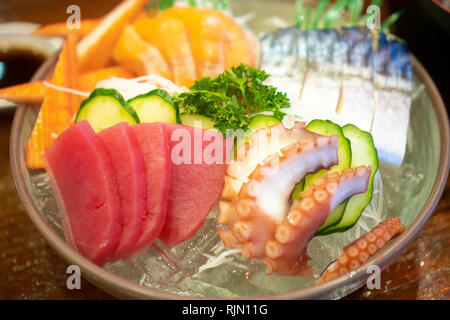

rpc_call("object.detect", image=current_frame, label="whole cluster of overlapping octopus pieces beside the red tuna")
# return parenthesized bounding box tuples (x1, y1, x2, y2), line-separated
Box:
(218, 122, 371, 275)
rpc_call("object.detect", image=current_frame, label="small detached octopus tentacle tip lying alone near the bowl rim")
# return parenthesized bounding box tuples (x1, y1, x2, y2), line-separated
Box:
(317, 217, 404, 284)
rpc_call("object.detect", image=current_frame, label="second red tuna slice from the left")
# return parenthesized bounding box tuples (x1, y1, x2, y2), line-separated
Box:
(98, 122, 147, 259)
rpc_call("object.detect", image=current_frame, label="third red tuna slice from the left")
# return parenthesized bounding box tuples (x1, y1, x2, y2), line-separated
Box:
(130, 122, 171, 254)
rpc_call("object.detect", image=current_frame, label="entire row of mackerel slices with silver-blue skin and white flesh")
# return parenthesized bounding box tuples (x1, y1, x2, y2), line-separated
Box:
(261, 27, 412, 165)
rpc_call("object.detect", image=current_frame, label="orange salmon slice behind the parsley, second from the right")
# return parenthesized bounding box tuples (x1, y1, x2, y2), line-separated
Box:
(162, 7, 226, 77)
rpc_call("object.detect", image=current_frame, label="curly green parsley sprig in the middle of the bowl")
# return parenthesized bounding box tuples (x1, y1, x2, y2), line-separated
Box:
(173, 64, 290, 136)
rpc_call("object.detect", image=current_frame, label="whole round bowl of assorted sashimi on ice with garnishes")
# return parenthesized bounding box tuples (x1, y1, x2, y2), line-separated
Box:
(6, 0, 446, 298)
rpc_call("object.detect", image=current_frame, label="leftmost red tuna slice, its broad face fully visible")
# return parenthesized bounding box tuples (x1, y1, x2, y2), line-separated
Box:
(45, 120, 122, 265)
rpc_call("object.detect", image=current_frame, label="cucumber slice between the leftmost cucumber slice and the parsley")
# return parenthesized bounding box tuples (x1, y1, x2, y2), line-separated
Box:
(127, 89, 181, 123)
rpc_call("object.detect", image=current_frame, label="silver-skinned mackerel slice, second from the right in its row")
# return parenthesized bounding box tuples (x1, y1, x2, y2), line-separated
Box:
(338, 28, 375, 131)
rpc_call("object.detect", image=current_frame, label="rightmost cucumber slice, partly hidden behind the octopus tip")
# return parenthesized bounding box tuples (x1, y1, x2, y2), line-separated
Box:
(322, 124, 378, 234)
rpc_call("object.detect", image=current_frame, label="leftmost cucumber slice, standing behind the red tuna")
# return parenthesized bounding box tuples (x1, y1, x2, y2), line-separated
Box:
(75, 88, 139, 132)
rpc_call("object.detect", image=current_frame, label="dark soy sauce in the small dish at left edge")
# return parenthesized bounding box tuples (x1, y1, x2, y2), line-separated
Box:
(0, 49, 46, 88)
